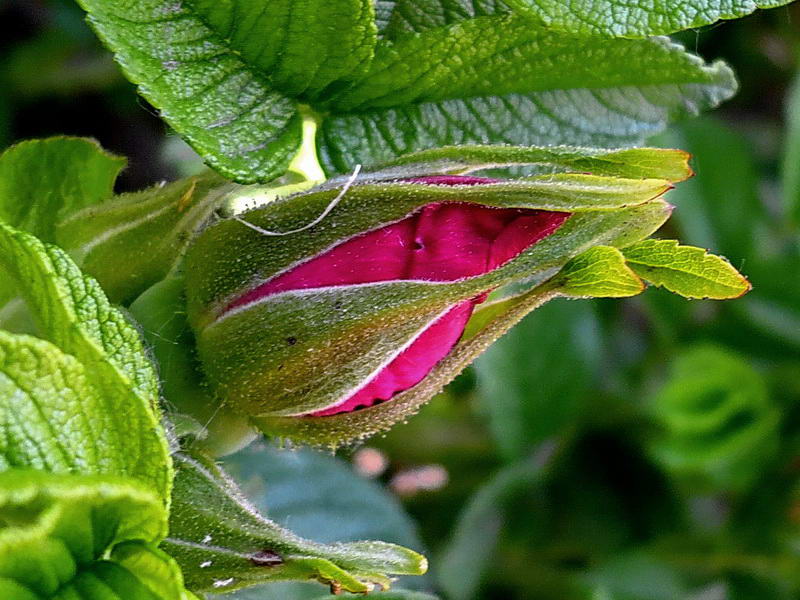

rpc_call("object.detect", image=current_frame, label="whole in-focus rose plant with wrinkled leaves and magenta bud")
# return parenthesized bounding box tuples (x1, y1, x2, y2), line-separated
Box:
(0, 0, 775, 600)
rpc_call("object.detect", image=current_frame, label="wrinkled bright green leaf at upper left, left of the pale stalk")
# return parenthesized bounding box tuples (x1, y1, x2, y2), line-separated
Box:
(74, 0, 375, 181)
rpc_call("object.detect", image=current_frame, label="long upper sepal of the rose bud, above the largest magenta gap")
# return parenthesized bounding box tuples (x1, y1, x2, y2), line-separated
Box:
(186, 146, 691, 328)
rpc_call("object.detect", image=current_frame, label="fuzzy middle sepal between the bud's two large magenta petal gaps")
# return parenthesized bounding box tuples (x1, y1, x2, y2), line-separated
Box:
(198, 200, 670, 424)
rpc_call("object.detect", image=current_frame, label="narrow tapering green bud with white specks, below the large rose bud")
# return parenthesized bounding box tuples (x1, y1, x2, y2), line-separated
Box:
(163, 454, 427, 593)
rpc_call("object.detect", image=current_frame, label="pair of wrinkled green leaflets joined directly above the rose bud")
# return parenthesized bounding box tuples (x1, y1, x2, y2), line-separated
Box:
(76, 0, 735, 182)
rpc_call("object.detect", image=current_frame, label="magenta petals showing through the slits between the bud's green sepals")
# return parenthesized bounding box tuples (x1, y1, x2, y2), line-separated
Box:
(229, 176, 570, 416)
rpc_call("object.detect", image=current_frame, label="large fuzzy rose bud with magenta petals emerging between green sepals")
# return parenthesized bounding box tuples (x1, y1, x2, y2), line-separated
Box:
(186, 148, 688, 444)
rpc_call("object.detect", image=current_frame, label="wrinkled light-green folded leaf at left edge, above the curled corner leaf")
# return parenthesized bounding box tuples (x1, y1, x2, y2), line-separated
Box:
(0, 224, 171, 502)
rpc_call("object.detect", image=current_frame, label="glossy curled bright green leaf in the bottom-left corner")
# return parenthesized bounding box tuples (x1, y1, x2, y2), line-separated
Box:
(0, 469, 190, 600)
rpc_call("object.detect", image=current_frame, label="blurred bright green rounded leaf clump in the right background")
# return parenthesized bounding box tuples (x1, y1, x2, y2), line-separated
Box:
(652, 346, 779, 490)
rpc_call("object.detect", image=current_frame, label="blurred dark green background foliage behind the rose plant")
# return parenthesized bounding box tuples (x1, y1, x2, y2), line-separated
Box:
(0, 0, 800, 600)
